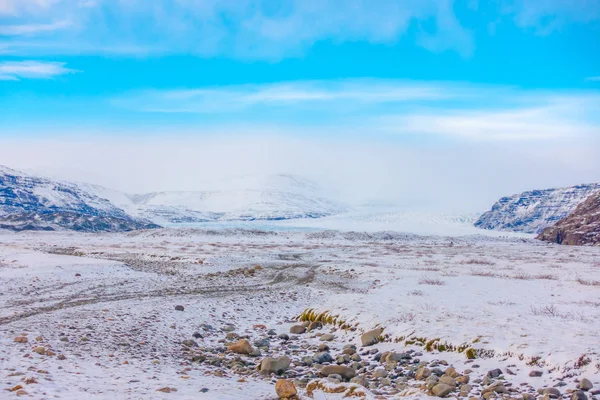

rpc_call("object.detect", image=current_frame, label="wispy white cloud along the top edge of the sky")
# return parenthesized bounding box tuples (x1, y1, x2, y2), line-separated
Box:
(0, 0, 473, 59)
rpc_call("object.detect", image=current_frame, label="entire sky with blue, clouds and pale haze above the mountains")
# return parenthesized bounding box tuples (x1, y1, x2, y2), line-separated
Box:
(0, 0, 600, 212)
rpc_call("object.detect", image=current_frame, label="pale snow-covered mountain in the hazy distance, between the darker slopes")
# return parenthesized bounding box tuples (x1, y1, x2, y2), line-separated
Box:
(82, 175, 345, 224)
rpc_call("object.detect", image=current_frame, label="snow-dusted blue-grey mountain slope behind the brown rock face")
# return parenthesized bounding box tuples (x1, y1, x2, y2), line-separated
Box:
(475, 183, 600, 233)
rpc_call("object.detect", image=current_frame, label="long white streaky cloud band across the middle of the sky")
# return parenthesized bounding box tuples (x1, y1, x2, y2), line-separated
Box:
(112, 79, 600, 141)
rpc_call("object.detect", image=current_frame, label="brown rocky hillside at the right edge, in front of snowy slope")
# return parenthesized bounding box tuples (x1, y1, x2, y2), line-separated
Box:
(537, 192, 600, 246)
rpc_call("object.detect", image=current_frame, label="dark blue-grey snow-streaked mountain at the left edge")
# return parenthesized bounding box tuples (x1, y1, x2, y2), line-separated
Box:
(0, 166, 158, 232)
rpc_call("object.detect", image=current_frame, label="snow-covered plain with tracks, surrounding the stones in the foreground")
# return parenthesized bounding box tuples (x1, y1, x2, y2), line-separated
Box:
(0, 228, 600, 399)
